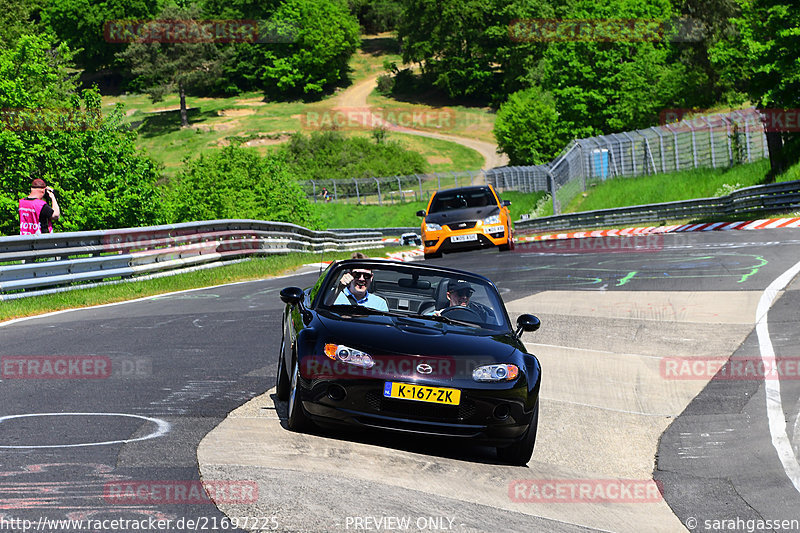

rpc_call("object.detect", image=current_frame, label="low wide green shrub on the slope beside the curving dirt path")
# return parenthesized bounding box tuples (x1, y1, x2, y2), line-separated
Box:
(285, 131, 427, 180)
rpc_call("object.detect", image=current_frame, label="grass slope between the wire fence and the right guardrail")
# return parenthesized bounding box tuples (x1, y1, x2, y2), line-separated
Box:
(563, 160, 769, 213)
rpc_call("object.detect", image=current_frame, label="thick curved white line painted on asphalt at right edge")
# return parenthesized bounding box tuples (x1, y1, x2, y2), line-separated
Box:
(756, 262, 800, 492)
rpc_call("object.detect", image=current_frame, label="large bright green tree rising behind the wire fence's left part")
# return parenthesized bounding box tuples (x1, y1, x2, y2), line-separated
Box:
(530, 0, 685, 137)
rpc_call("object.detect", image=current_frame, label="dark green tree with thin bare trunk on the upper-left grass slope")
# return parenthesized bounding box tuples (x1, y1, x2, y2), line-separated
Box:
(118, 4, 233, 128)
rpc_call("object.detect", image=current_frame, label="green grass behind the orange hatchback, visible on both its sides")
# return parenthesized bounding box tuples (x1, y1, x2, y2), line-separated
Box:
(314, 191, 544, 228)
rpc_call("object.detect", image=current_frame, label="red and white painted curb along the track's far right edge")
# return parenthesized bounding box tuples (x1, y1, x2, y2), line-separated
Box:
(514, 217, 800, 242)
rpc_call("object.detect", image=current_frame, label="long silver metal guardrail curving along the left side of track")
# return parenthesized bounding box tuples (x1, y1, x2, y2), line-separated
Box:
(0, 220, 382, 300)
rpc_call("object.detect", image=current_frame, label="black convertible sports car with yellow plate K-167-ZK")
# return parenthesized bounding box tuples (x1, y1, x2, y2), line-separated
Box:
(277, 259, 541, 465)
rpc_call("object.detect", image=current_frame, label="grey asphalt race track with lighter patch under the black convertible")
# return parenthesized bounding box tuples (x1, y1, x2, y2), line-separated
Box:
(0, 229, 800, 532)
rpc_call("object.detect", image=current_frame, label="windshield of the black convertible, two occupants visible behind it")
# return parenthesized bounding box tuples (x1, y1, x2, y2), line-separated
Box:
(315, 261, 510, 332)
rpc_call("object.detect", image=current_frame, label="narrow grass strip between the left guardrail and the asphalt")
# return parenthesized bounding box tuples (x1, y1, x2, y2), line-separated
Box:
(0, 247, 400, 321)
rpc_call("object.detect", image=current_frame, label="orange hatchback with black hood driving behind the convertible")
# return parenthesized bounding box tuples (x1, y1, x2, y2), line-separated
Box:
(417, 185, 514, 259)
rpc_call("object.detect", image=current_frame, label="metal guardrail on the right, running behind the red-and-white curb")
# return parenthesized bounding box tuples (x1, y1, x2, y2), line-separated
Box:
(515, 181, 800, 232)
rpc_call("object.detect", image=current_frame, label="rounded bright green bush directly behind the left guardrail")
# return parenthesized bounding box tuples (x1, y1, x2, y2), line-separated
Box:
(164, 145, 318, 228)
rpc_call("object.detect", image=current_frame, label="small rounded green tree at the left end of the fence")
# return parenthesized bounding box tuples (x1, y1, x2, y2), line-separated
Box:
(494, 87, 570, 165)
